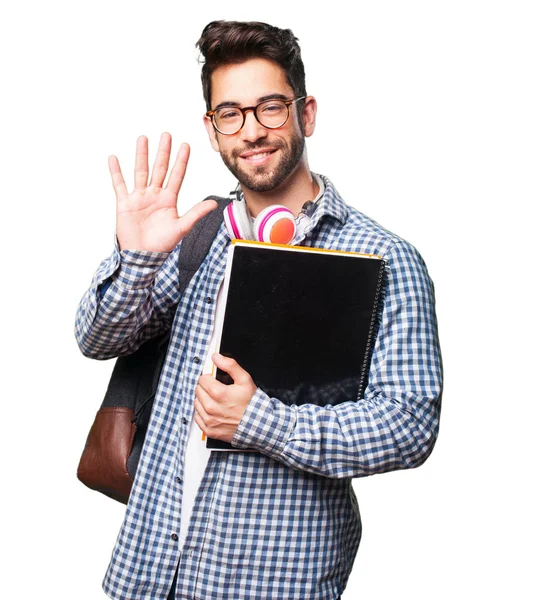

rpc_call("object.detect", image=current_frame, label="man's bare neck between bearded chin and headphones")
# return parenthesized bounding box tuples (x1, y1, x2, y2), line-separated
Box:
(242, 156, 319, 217)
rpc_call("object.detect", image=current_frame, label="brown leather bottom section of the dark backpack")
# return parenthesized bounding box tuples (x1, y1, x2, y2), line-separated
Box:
(77, 406, 137, 504)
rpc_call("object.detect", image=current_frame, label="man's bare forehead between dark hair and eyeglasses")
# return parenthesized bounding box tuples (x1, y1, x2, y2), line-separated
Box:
(211, 58, 293, 108)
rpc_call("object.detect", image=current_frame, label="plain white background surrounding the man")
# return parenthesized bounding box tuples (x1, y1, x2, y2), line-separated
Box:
(0, 0, 548, 600)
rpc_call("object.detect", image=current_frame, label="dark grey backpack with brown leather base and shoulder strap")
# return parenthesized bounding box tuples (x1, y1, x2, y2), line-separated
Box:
(77, 196, 230, 504)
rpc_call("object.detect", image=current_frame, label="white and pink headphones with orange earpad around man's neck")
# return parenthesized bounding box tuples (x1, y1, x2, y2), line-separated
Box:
(223, 173, 325, 244)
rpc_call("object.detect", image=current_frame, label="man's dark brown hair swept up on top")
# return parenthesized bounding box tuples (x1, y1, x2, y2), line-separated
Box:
(196, 21, 306, 114)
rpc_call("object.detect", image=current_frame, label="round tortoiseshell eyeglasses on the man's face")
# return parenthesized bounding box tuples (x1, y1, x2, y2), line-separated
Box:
(206, 96, 306, 135)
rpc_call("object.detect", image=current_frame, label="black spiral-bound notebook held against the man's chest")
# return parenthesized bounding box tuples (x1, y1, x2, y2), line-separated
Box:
(207, 241, 385, 450)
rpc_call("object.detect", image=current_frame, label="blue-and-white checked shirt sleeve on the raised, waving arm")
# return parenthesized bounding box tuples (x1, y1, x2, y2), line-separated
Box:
(74, 237, 180, 360)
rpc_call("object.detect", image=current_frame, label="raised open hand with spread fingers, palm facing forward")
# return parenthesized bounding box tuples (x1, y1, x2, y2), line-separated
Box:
(108, 132, 217, 252)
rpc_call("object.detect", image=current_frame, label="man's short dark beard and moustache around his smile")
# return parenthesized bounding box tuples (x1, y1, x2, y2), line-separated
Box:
(221, 132, 305, 192)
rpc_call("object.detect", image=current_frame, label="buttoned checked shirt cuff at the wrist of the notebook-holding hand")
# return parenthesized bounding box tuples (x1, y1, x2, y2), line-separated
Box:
(232, 388, 297, 458)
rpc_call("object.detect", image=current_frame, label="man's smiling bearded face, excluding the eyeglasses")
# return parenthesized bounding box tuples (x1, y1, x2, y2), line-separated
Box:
(205, 58, 305, 192)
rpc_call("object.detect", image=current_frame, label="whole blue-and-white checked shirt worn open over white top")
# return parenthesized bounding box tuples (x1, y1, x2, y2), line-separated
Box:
(75, 177, 442, 600)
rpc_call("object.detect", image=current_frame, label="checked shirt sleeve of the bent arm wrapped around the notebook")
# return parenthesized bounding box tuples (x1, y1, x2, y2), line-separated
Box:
(232, 240, 442, 478)
